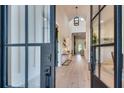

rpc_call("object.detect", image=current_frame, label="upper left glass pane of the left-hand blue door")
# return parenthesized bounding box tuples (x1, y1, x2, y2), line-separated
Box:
(7, 5, 25, 43)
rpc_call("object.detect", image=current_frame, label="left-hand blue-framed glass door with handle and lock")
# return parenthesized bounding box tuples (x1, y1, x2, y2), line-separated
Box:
(2, 5, 55, 88)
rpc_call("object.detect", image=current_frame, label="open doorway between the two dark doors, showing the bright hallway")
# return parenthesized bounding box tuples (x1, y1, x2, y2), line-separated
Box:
(56, 5, 90, 88)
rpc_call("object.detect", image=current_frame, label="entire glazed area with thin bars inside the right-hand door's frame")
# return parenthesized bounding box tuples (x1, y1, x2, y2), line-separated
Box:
(92, 6, 114, 87)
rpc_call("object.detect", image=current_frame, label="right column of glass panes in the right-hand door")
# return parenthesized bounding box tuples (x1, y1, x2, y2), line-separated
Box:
(100, 6, 114, 87)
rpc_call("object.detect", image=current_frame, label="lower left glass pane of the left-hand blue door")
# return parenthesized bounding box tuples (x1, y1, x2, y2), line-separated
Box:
(7, 47, 25, 87)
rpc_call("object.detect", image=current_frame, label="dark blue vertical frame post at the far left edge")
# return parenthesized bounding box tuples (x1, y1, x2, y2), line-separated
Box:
(0, 6, 6, 87)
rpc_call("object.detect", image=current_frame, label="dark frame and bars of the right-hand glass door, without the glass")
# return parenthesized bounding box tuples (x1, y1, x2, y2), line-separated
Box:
(90, 5, 123, 88)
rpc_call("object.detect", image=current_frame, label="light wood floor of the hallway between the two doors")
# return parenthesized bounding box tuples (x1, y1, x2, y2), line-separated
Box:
(56, 55, 90, 88)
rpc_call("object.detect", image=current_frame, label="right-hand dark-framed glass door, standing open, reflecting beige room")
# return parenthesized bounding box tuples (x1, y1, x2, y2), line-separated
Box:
(91, 5, 122, 87)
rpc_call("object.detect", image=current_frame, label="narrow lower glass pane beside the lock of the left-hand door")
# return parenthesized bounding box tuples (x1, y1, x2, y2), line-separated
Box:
(28, 47, 41, 88)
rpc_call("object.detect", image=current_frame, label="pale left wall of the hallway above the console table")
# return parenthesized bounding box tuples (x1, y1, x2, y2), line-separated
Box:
(56, 6, 71, 65)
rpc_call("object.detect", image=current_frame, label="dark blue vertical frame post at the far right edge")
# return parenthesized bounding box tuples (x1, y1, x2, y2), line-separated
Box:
(114, 5, 123, 88)
